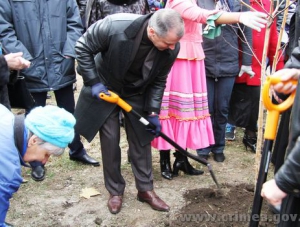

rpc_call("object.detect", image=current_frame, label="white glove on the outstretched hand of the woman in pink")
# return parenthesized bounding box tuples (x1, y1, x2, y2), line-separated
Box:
(239, 11, 268, 32)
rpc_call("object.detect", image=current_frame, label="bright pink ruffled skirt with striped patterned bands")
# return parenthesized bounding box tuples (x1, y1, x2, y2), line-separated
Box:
(152, 59, 214, 150)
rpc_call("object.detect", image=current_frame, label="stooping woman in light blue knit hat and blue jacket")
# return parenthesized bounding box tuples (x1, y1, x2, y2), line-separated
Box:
(0, 104, 76, 227)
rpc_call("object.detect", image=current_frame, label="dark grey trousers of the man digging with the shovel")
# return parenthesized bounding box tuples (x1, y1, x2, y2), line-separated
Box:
(99, 106, 153, 195)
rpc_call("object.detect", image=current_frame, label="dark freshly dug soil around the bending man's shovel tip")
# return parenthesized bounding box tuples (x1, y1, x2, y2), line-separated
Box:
(170, 184, 276, 227)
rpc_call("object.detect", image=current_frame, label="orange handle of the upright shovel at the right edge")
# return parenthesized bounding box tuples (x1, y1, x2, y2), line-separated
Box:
(262, 76, 298, 140)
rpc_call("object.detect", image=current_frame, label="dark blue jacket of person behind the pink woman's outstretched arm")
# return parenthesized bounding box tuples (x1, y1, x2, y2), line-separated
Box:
(197, 0, 252, 78)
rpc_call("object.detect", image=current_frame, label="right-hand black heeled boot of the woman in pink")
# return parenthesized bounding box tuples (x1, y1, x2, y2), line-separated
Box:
(173, 151, 204, 177)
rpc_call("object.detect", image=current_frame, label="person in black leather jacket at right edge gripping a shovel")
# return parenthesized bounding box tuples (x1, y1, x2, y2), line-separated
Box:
(261, 68, 300, 227)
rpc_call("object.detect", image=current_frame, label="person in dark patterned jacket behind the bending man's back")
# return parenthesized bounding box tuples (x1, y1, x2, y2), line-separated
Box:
(85, 0, 150, 28)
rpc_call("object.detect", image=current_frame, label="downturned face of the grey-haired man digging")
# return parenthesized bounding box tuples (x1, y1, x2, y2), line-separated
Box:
(148, 27, 180, 51)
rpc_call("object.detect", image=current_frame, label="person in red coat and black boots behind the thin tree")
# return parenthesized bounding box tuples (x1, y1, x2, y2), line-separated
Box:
(227, 0, 284, 153)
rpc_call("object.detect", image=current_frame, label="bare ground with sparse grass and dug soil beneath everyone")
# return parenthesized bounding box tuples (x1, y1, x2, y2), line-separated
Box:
(6, 77, 275, 227)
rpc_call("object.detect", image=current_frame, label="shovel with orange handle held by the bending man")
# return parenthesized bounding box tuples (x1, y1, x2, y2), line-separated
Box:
(99, 91, 220, 188)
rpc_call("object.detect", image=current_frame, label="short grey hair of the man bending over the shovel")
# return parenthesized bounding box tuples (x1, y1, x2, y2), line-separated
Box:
(149, 9, 184, 38)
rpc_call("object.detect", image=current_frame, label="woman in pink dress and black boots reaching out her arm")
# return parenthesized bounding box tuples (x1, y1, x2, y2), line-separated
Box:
(152, 0, 266, 180)
